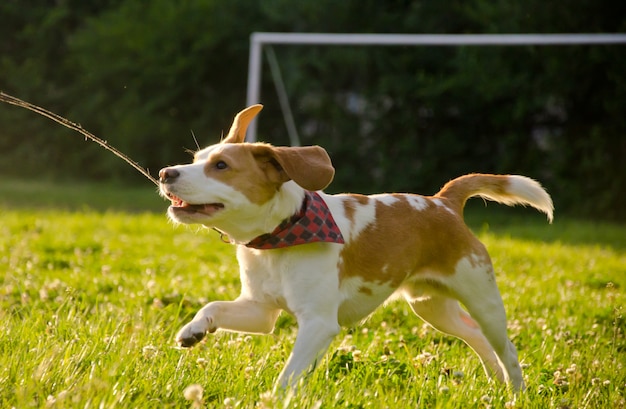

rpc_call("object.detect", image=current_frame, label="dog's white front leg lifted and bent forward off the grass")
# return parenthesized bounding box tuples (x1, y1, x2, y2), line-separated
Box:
(176, 298, 280, 347)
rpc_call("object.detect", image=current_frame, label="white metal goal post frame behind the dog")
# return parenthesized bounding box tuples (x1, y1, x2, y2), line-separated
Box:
(246, 32, 626, 142)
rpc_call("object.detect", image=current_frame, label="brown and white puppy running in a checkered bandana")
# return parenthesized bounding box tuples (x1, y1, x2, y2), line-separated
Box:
(159, 105, 554, 391)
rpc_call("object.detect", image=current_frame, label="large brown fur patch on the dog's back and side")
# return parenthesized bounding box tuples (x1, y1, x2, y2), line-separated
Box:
(340, 195, 486, 287)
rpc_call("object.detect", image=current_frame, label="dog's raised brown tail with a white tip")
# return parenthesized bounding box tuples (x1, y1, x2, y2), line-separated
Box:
(435, 174, 554, 223)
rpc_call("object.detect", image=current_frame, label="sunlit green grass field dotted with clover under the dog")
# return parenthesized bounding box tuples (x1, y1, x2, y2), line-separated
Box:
(0, 181, 626, 408)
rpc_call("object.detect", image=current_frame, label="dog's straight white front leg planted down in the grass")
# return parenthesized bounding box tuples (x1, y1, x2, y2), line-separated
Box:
(276, 317, 340, 388)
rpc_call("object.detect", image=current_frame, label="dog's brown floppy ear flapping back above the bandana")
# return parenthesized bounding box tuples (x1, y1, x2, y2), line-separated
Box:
(256, 145, 335, 191)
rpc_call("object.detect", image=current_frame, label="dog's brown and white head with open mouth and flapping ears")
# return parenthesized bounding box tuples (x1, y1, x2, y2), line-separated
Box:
(159, 105, 335, 233)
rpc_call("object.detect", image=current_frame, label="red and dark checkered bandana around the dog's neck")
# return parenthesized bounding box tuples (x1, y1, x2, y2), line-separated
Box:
(246, 191, 344, 250)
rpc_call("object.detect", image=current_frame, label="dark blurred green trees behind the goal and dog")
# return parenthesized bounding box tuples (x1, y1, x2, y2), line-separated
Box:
(0, 0, 626, 221)
